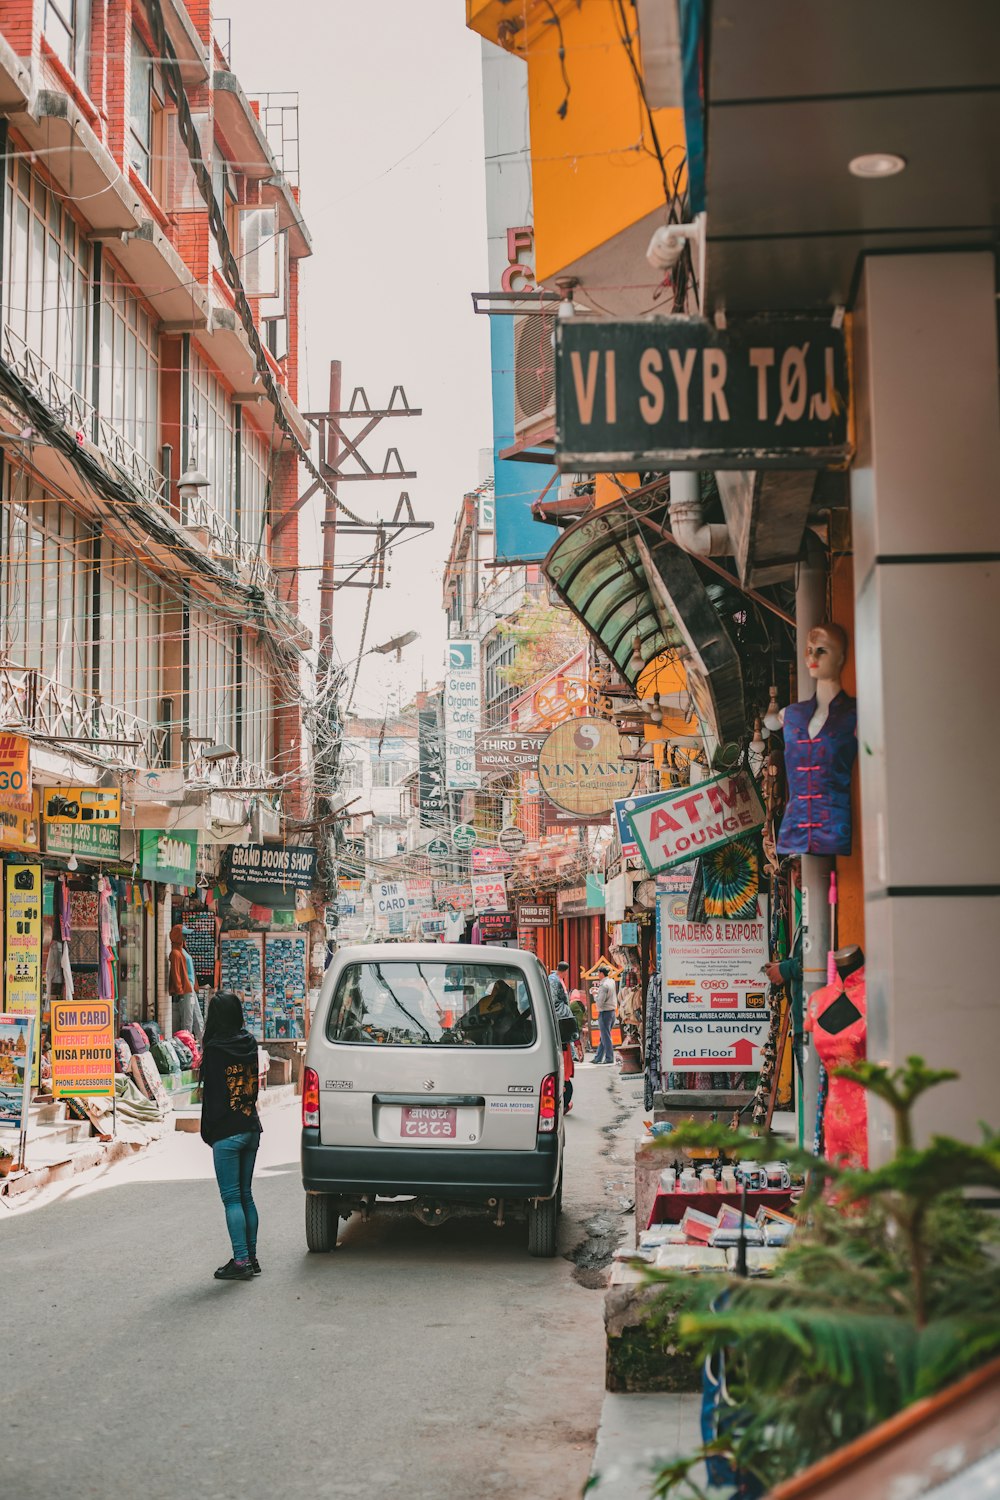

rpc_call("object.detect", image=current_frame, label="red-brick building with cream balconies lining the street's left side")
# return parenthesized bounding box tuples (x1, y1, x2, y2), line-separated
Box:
(0, 0, 319, 1032)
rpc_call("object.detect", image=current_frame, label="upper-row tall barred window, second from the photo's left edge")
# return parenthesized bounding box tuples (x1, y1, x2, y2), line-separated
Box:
(97, 257, 159, 465)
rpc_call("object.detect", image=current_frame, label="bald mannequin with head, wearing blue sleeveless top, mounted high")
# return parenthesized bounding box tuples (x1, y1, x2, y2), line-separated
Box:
(778, 624, 858, 855)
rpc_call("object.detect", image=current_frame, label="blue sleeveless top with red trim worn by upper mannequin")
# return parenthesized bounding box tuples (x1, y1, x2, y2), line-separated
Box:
(778, 692, 858, 854)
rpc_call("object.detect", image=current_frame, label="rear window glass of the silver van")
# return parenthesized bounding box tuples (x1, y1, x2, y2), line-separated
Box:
(327, 960, 535, 1047)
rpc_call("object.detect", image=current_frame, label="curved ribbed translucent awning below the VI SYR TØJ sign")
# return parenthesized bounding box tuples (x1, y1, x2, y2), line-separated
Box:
(543, 495, 747, 744)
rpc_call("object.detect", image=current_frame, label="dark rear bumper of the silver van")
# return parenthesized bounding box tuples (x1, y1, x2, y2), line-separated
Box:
(301, 1130, 559, 1203)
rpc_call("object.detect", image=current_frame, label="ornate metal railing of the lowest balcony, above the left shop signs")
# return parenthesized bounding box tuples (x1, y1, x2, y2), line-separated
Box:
(0, 666, 169, 770)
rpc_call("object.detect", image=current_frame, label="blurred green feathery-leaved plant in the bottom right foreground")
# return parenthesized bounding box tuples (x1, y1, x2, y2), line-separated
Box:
(641, 1058, 1000, 1497)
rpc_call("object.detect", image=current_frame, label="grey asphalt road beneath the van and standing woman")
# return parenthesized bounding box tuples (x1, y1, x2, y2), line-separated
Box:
(0, 1065, 640, 1500)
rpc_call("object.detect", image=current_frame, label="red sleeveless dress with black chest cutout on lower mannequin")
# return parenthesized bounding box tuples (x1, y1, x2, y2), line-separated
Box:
(805, 968, 868, 1167)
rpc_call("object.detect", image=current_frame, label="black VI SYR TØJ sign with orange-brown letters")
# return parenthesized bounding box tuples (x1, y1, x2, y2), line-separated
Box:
(556, 318, 850, 473)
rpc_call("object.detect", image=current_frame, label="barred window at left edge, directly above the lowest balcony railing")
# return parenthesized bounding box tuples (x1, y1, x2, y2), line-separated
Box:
(0, 486, 91, 698)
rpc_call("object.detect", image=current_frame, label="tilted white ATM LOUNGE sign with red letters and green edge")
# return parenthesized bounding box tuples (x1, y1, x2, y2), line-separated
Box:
(625, 771, 765, 875)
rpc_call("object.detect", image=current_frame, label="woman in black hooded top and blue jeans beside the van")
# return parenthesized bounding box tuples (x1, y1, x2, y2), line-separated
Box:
(199, 990, 261, 1281)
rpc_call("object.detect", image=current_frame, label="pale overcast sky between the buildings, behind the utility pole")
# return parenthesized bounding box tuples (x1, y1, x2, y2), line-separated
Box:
(231, 0, 492, 714)
